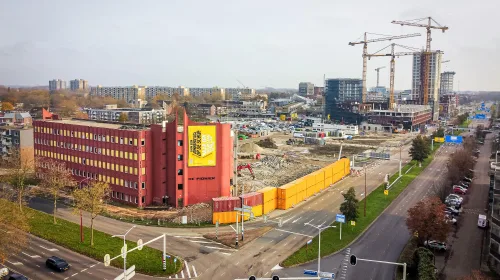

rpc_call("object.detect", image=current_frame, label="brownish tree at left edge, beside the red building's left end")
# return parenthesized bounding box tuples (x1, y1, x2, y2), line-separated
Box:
(1, 149, 34, 212)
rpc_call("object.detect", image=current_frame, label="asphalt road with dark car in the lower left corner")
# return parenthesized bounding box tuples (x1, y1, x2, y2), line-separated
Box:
(0, 236, 122, 280)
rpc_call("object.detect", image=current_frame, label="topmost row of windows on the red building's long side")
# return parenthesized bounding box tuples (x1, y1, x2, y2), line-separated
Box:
(35, 126, 146, 146)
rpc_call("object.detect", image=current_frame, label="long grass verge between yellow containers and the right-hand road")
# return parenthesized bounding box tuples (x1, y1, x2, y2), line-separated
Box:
(281, 143, 441, 267)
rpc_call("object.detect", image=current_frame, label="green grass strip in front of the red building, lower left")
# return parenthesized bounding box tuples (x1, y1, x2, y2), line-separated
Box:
(19, 204, 183, 276)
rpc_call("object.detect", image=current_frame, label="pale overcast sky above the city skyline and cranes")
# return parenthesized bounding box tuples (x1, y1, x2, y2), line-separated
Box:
(0, 0, 500, 90)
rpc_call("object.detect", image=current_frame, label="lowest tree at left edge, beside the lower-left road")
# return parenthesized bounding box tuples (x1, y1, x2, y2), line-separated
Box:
(0, 191, 29, 263)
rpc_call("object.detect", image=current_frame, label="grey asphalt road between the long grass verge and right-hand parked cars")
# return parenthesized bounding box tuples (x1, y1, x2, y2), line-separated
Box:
(279, 143, 455, 279)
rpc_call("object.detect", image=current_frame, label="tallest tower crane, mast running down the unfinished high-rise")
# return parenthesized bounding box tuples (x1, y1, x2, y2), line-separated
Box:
(391, 17, 448, 105)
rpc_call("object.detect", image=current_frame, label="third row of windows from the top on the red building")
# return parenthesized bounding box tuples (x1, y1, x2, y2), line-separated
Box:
(35, 150, 146, 175)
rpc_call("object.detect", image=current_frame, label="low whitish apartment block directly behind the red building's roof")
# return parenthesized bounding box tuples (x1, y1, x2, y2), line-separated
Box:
(86, 108, 166, 124)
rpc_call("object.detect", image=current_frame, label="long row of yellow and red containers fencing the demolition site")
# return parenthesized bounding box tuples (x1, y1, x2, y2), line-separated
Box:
(214, 158, 351, 223)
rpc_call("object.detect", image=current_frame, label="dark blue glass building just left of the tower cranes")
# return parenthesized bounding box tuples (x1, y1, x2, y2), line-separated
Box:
(324, 78, 363, 124)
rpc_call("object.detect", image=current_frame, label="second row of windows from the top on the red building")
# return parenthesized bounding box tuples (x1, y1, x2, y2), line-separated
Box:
(35, 138, 146, 160)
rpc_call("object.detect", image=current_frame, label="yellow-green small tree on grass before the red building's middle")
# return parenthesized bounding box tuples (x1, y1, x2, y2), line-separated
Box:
(73, 181, 111, 247)
